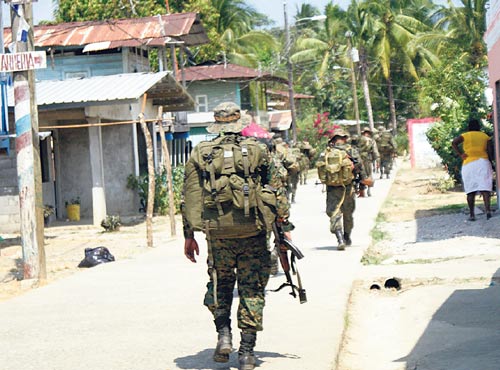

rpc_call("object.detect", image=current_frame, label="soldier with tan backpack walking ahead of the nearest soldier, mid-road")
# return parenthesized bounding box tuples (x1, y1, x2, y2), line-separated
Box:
(316, 129, 363, 250)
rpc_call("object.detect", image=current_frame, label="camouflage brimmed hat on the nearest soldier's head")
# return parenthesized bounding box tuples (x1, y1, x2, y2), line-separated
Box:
(207, 102, 252, 134)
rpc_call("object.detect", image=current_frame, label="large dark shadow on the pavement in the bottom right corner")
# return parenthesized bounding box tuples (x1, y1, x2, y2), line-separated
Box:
(397, 269, 500, 370)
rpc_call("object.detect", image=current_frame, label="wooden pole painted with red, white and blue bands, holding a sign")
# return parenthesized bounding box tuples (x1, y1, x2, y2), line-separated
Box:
(11, 2, 47, 280)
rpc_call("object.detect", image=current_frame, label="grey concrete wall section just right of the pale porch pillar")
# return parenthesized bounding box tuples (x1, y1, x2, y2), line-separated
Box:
(102, 125, 140, 216)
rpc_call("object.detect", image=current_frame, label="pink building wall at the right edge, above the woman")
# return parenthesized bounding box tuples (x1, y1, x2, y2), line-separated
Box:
(484, 0, 500, 193)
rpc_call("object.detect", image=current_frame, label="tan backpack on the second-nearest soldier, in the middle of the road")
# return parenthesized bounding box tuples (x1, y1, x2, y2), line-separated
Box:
(316, 147, 354, 186)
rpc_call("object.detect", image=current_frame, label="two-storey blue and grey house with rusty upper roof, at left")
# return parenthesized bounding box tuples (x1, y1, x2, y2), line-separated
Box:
(0, 13, 208, 232)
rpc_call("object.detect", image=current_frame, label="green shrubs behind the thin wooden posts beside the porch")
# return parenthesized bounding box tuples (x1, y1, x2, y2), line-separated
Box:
(127, 166, 184, 216)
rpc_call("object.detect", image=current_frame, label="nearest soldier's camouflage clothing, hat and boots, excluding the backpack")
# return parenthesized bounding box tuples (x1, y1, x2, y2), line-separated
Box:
(183, 103, 293, 369)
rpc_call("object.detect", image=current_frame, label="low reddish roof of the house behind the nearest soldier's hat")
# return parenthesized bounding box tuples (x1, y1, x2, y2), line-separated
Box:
(182, 63, 287, 83)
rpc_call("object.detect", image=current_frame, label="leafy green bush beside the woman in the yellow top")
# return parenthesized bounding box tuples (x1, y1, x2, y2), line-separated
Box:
(419, 59, 489, 181)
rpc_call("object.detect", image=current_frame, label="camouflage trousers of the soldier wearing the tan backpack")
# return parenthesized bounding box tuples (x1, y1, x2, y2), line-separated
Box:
(326, 184, 356, 234)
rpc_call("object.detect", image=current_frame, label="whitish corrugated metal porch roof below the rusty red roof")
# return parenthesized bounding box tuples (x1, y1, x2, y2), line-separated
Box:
(8, 72, 194, 111)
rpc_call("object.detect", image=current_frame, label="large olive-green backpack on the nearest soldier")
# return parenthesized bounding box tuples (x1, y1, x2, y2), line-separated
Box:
(182, 135, 276, 238)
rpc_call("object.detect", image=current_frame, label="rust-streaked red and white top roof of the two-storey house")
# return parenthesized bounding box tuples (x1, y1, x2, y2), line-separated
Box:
(4, 13, 209, 48)
